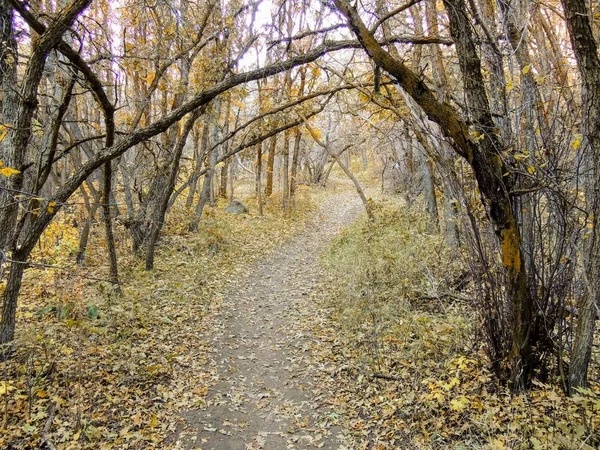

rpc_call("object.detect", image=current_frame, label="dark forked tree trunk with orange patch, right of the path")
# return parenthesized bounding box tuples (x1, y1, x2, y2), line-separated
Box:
(335, 0, 535, 389)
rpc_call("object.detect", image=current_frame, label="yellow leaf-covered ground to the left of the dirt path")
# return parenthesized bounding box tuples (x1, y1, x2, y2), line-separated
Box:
(0, 185, 316, 449)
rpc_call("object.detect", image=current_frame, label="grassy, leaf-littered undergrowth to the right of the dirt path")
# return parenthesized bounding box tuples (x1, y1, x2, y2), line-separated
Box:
(320, 202, 600, 450)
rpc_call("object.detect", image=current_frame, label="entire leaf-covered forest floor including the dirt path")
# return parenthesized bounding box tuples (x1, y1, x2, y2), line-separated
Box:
(0, 179, 600, 450)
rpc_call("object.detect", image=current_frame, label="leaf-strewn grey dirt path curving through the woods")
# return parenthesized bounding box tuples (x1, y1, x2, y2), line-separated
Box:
(175, 192, 361, 450)
